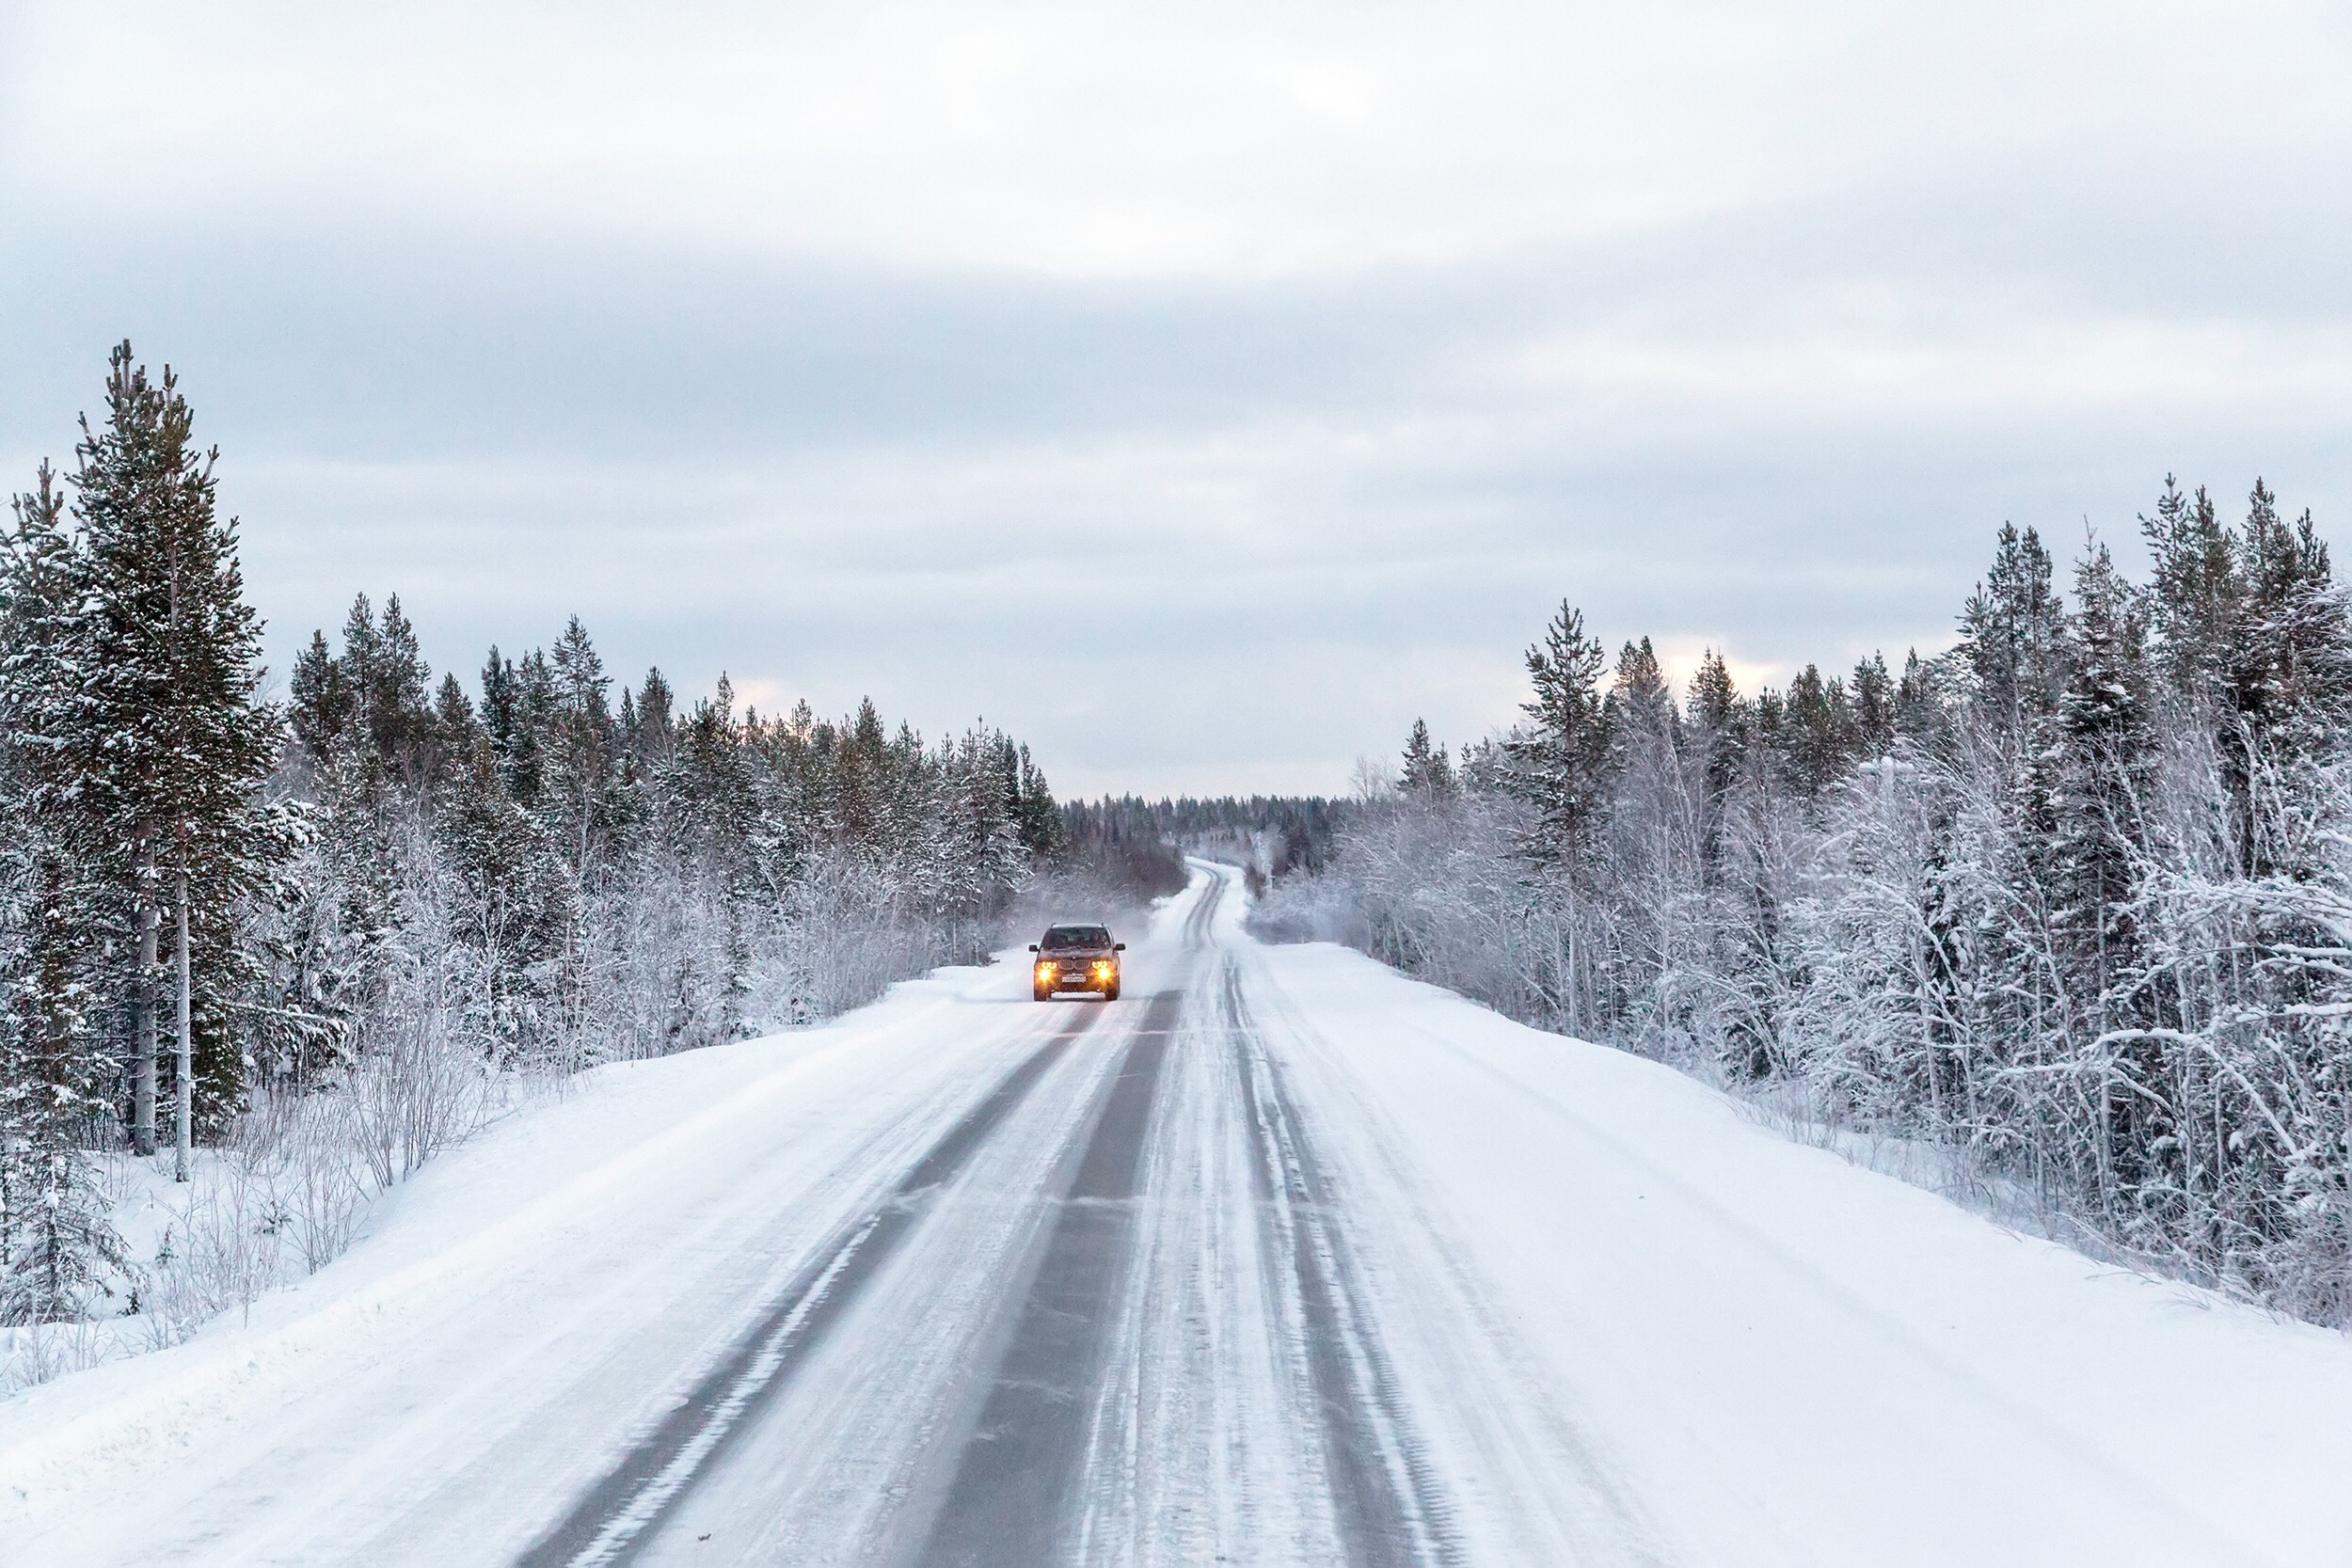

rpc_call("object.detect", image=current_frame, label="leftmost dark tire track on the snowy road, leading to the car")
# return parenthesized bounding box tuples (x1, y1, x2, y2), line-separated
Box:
(517, 1008, 1104, 1568)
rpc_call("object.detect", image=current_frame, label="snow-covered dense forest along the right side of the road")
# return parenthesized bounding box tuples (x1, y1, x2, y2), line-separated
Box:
(1259, 482, 2352, 1323)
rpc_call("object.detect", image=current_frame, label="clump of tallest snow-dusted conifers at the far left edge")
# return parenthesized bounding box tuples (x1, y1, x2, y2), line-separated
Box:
(0, 343, 280, 1319)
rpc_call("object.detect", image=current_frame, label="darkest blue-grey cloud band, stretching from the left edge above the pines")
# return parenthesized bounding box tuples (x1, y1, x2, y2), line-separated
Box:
(5, 217, 1486, 458)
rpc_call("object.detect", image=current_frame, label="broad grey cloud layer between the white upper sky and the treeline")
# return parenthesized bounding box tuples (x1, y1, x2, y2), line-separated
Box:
(0, 140, 2352, 790)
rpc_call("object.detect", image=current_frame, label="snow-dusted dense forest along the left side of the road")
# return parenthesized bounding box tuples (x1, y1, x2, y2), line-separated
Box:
(0, 345, 1082, 1323)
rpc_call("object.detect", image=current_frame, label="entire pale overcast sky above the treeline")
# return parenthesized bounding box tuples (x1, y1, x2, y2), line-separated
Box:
(0, 0, 2352, 795)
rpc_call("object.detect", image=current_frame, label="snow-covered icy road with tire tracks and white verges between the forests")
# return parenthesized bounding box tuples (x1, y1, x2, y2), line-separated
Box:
(0, 867, 2352, 1568)
